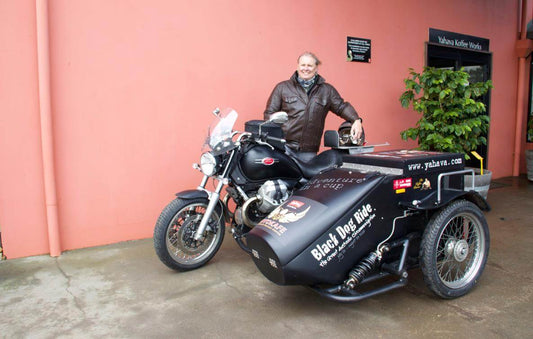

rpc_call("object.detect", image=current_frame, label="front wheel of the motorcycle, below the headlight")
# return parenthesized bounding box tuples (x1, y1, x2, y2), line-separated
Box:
(154, 198, 225, 271)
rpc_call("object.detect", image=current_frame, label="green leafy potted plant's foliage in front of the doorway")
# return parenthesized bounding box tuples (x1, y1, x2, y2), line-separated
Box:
(400, 67, 492, 159)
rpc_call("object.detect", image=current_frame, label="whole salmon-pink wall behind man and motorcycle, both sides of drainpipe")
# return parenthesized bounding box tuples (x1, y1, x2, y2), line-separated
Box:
(0, 0, 518, 258)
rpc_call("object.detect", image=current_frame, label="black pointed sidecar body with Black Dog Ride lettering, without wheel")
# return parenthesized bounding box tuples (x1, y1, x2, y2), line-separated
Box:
(246, 168, 407, 285)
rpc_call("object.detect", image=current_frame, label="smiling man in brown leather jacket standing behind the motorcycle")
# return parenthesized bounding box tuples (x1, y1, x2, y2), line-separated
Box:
(264, 52, 363, 161)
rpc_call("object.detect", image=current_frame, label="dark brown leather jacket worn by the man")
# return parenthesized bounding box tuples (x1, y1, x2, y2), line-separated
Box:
(264, 72, 359, 152)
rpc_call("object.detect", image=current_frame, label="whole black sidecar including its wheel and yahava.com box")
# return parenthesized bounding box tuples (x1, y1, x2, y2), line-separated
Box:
(246, 150, 490, 302)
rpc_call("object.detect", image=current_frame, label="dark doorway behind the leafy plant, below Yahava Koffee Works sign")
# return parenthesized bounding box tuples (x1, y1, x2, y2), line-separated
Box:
(426, 43, 492, 168)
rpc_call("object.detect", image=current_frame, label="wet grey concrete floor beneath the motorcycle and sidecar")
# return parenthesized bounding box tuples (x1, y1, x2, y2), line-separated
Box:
(0, 177, 533, 339)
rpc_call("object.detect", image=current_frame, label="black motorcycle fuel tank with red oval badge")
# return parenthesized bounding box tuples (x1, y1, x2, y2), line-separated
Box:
(238, 145, 302, 181)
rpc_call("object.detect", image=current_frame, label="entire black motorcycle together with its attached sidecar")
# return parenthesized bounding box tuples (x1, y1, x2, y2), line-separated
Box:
(154, 107, 490, 302)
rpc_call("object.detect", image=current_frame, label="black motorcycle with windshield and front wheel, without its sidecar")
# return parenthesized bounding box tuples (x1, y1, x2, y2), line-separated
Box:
(154, 108, 342, 271)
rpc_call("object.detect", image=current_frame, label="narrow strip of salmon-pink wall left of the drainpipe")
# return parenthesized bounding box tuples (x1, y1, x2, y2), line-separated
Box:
(0, 1, 48, 258)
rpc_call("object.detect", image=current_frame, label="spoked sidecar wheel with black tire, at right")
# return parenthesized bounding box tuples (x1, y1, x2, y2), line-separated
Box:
(420, 200, 490, 299)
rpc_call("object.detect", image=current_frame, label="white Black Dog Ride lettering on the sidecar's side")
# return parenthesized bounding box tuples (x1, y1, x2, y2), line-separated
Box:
(310, 204, 376, 267)
